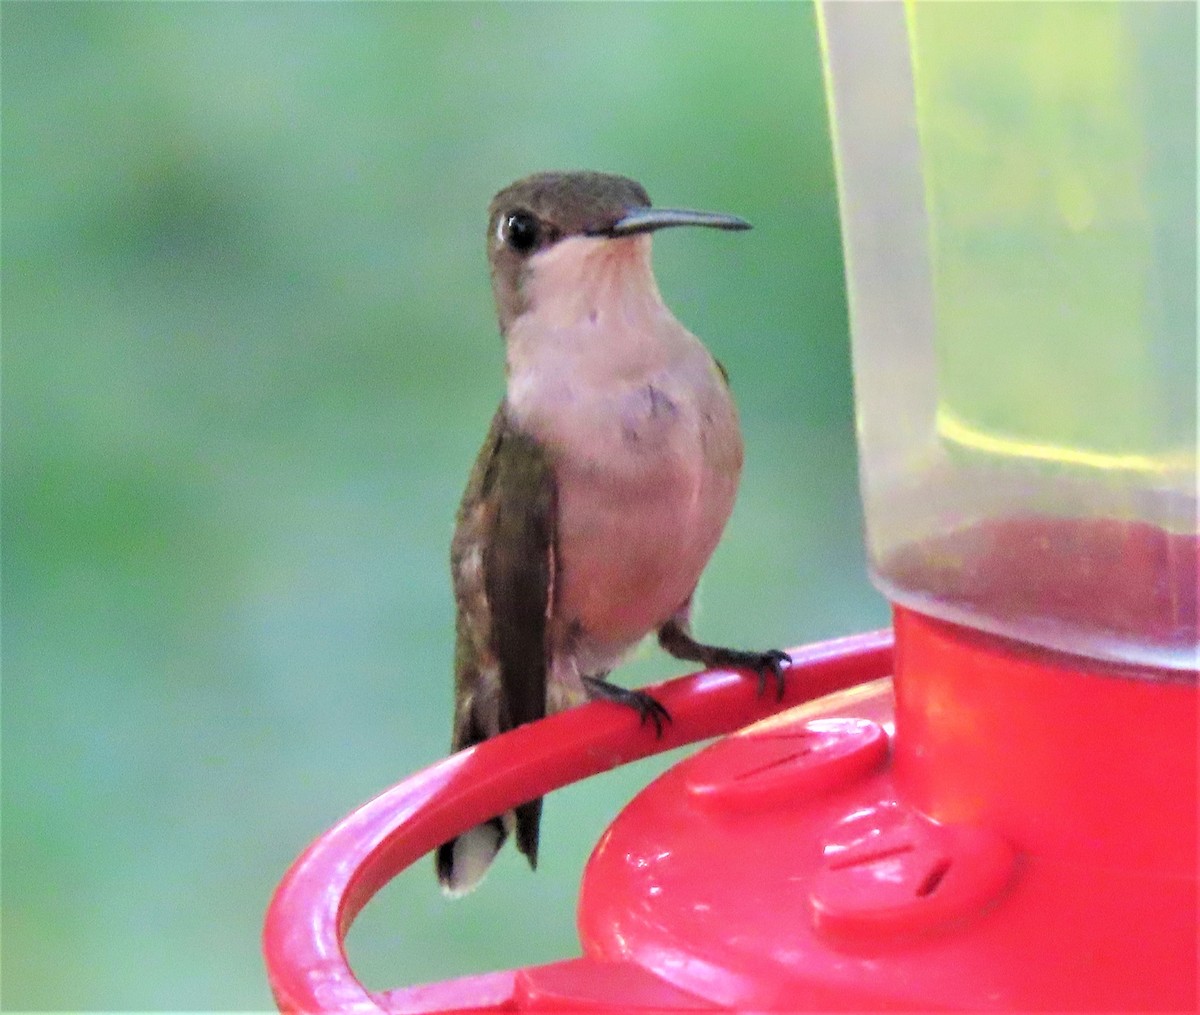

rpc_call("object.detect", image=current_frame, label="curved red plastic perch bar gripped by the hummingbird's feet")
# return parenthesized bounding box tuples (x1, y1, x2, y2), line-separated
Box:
(263, 630, 893, 1011)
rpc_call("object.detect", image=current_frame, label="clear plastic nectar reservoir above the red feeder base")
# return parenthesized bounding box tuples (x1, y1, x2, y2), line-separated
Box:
(820, 2, 1200, 669)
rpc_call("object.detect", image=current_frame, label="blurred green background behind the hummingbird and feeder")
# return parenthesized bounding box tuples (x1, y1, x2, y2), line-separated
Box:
(0, 0, 887, 1009)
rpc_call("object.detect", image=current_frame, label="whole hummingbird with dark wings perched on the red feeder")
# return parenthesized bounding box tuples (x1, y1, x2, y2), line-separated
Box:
(436, 172, 791, 896)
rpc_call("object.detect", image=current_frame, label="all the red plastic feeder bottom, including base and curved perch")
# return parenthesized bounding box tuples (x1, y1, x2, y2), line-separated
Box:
(264, 609, 1198, 1013)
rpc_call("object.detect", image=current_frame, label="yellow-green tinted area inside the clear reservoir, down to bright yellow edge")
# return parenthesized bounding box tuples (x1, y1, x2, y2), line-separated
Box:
(906, 0, 1196, 484)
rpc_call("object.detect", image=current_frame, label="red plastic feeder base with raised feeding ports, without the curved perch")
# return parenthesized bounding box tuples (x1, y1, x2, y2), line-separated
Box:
(580, 609, 1198, 1011)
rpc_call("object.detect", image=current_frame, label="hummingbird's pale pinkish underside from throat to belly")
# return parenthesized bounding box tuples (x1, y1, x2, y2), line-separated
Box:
(505, 235, 742, 672)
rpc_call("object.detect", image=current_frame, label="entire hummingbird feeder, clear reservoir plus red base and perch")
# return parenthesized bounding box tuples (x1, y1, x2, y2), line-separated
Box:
(264, 2, 1200, 1013)
